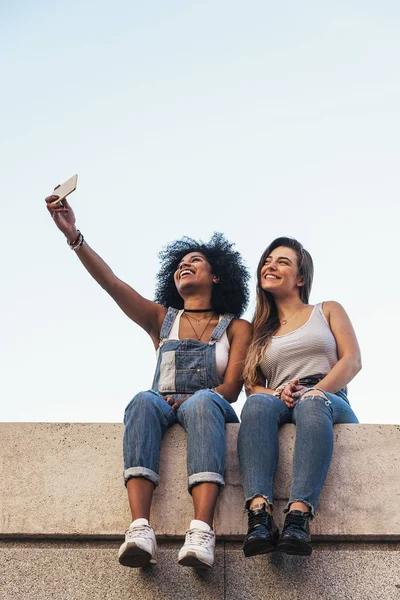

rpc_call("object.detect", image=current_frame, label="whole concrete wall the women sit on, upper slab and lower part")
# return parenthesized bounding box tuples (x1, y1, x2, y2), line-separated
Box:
(0, 423, 400, 600)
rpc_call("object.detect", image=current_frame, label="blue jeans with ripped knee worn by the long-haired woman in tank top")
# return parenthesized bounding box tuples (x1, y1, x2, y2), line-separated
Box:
(238, 391, 358, 516)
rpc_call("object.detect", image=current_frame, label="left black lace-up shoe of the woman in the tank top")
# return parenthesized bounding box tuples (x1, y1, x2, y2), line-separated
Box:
(243, 504, 279, 556)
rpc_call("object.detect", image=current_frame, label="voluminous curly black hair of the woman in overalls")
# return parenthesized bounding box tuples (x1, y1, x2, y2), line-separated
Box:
(155, 232, 250, 317)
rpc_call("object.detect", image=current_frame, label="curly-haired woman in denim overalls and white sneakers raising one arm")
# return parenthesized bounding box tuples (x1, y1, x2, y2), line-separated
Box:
(46, 195, 251, 567)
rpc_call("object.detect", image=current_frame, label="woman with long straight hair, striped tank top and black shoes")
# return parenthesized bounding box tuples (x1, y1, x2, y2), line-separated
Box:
(238, 237, 361, 556)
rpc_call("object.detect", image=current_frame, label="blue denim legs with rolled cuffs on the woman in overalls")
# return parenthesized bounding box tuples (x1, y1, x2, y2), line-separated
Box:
(124, 389, 239, 491)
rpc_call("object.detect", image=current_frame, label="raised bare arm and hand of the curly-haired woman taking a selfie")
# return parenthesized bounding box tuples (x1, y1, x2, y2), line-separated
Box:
(46, 195, 167, 347)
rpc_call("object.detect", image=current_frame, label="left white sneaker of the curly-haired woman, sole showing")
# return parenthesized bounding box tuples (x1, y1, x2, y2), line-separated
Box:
(118, 519, 157, 567)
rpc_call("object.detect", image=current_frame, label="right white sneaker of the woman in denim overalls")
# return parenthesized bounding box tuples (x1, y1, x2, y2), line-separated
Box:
(178, 519, 215, 568)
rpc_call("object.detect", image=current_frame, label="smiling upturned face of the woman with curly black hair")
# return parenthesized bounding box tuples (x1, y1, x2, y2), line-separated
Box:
(174, 252, 218, 296)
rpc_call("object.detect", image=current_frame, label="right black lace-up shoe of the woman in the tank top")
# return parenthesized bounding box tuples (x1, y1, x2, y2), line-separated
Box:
(278, 510, 312, 556)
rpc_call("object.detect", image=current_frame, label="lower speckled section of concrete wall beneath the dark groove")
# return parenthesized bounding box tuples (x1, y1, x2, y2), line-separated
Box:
(0, 541, 400, 600)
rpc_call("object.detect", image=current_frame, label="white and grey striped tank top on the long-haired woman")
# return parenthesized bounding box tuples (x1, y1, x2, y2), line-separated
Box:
(260, 303, 338, 390)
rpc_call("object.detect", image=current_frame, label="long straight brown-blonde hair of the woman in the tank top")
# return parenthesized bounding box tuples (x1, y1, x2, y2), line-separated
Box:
(243, 237, 314, 388)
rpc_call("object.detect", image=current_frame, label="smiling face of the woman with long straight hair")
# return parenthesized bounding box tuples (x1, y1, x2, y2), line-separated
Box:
(260, 246, 304, 296)
